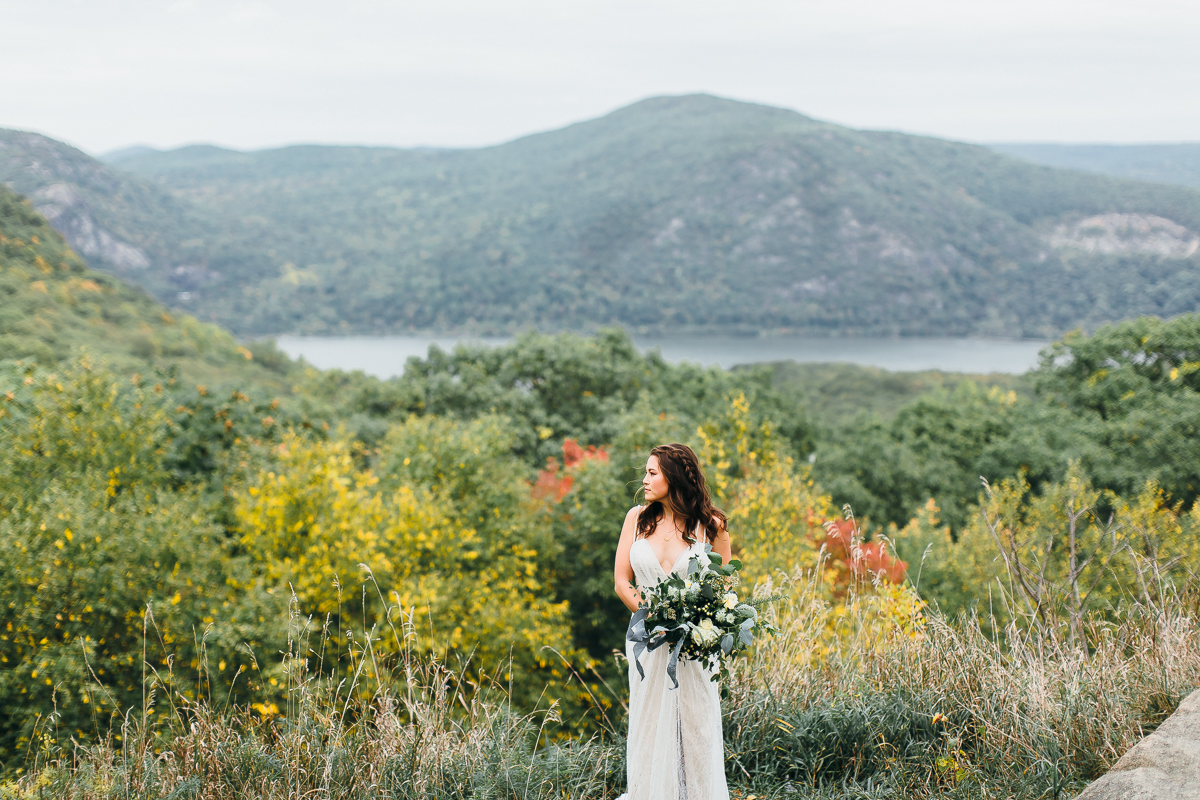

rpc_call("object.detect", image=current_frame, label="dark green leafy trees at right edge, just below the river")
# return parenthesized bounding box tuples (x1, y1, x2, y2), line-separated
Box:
(814, 314, 1200, 531)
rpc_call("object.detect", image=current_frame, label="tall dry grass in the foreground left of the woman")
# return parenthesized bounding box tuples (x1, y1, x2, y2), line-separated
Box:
(0, 599, 624, 800)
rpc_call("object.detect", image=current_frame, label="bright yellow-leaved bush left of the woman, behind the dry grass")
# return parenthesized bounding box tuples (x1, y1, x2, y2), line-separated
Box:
(236, 419, 572, 703)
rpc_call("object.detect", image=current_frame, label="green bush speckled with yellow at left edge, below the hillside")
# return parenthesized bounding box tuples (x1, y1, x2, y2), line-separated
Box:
(0, 362, 283, 766)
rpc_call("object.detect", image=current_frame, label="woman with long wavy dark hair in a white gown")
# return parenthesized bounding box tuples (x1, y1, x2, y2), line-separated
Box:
(613, 444, 731, 800)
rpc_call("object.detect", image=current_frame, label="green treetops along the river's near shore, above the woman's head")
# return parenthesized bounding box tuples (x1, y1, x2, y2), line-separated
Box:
(301, 329, 815, 467)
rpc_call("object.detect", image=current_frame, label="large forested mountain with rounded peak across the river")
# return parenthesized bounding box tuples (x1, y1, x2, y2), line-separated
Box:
(7, 95, 1200, 336)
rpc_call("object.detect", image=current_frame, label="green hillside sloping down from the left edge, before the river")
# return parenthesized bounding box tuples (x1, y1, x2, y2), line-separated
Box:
(0, 186, 292, 393)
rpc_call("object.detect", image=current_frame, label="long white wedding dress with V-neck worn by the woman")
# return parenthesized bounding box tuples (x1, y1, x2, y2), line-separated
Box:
(622, 536, 730, 800)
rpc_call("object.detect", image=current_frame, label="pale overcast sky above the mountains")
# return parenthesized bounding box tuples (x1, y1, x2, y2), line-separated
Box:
(0, 0, 1200, 154)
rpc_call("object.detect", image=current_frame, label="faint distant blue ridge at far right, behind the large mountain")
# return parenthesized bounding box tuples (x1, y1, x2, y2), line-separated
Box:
(991, 143, 1200, 187)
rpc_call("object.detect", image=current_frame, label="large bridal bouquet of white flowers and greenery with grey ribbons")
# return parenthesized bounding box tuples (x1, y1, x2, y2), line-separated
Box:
(626, 545, 778, 687)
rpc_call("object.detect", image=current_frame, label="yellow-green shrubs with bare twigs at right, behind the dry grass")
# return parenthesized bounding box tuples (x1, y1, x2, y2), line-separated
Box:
(892, 463, 1200, 628)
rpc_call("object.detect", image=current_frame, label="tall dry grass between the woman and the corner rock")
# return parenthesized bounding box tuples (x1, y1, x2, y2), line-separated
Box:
(725, 573, 1200, 798)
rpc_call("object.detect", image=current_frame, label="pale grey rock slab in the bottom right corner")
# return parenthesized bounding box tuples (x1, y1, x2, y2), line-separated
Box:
(1075, 691, 1200, 800)
